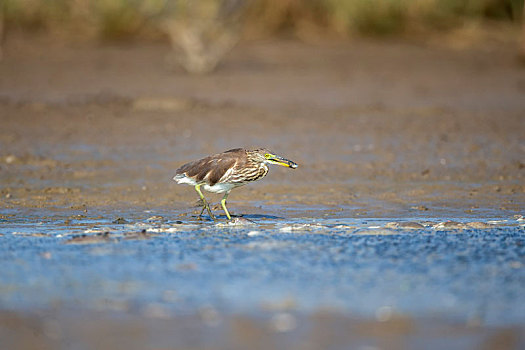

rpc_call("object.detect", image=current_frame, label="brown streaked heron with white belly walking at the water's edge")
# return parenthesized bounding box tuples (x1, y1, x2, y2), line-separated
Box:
(173, 148, 298, 221)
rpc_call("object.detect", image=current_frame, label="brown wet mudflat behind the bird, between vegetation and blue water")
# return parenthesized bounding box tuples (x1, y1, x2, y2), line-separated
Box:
(0, 37, 525, 217)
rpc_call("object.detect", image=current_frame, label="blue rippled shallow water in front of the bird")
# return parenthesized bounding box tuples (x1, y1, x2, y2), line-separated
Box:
(0, 209, 525, 325)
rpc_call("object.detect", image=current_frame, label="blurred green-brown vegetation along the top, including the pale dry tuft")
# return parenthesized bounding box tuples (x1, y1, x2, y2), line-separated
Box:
(1, 0, 525, 72)
